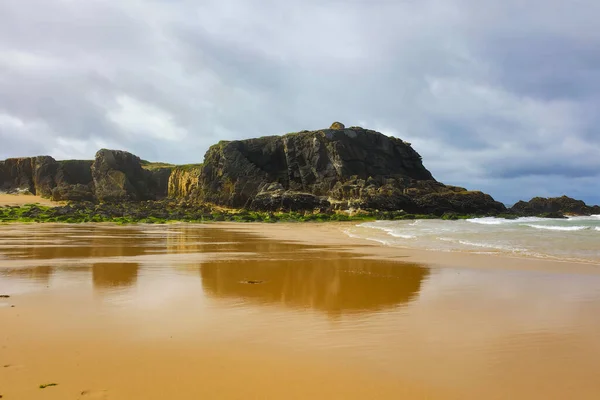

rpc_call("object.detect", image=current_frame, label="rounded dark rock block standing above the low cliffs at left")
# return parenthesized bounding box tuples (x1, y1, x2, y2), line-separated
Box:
(91, 149, 156, 202)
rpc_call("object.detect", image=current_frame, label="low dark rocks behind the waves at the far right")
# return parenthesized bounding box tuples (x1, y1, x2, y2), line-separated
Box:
(510, 196, 600, 216)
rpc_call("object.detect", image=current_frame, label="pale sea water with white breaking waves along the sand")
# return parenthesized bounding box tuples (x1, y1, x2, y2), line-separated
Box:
(346, 215, 600, 264)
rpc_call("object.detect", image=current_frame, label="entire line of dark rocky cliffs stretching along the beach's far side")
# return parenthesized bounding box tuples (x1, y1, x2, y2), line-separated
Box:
(0, 122, 600, 222)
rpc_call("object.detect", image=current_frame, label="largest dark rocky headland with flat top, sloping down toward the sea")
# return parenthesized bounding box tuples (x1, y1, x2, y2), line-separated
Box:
(198, 123, 505, 215)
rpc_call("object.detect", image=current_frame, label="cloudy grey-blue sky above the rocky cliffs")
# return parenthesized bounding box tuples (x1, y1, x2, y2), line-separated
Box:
(0, 0, 600, 204)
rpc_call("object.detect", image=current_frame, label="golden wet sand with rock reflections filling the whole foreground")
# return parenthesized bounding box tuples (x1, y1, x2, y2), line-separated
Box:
(0, 224, 600, 400)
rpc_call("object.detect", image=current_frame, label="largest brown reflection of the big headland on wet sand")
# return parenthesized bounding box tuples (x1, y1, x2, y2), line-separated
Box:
(200, 253, 428, 315)
